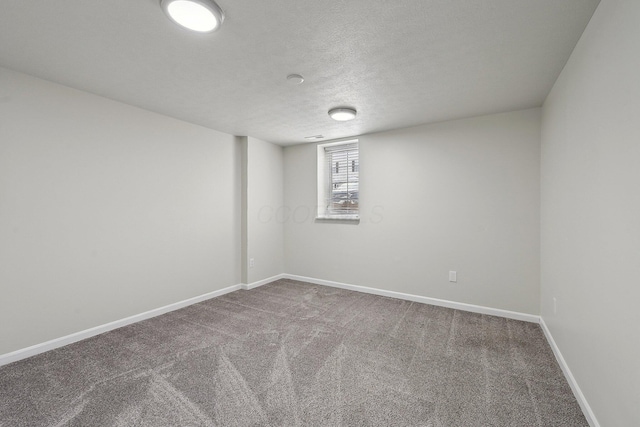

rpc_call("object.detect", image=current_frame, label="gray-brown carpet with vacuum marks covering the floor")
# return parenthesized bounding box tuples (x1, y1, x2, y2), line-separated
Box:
(0, 280, 588, 427)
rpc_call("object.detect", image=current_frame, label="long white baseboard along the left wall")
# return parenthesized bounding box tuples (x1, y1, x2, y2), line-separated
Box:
(0, 285, 242, 366)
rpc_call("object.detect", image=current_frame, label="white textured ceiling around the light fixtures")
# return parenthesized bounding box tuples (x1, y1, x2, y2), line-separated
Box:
(0, 0, 599, 145)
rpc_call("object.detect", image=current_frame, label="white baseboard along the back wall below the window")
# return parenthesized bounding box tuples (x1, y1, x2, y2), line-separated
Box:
(283, 274, 540, 323)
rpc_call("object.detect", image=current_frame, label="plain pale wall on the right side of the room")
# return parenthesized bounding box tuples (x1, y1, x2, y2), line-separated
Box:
(541, 0, 640, 426)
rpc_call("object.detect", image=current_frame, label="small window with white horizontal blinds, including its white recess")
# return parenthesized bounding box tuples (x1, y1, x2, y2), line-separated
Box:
(318, 140, 360, 220)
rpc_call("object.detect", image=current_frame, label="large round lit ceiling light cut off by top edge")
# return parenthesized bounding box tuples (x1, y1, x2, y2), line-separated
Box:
(160, 0, 224, 33)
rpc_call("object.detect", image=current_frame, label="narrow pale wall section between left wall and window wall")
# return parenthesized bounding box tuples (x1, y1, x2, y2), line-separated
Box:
(245, 137, 284, 283)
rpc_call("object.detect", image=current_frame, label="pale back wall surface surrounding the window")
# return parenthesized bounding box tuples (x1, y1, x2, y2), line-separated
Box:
(284, 109, 540, 314)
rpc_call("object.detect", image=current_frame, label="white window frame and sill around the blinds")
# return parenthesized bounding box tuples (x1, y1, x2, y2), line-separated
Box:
(316, 139, 360, 221)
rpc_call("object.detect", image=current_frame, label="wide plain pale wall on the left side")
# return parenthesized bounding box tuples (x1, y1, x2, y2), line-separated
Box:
(0, 68, 240, 354)
